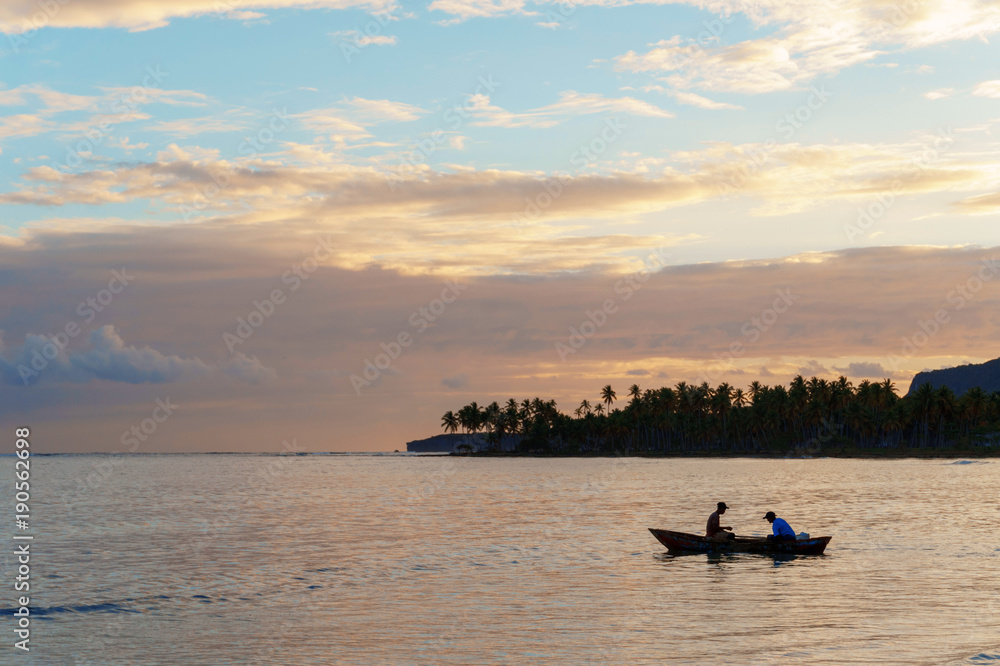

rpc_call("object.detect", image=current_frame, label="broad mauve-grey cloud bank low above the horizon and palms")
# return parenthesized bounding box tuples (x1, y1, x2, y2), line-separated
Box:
(7, 226, 1000, 450)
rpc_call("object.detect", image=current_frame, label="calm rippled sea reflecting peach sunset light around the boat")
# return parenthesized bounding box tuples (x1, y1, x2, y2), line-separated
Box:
(0, 456, 1000, 664)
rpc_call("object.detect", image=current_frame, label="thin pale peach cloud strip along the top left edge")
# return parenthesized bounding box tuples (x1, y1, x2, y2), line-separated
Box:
(0, 0, 394, 35)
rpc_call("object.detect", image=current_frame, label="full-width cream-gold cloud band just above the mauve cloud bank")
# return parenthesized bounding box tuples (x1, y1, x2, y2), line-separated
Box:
(0, 131, 998, 273)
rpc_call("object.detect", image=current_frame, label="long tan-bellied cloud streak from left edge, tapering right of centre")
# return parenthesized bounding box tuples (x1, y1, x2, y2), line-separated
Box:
(0, 148, 717, 224)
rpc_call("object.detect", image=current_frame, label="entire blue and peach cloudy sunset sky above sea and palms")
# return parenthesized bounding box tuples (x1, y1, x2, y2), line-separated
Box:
(0, 0, 1000, 452)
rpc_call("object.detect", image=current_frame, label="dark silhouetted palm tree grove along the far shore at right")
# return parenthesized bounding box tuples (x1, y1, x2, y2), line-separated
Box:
(441, 375, 1000, 454)
